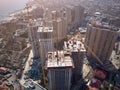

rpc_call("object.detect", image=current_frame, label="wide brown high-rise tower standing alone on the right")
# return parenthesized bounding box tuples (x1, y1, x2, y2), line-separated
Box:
(85, 23, 118, 62)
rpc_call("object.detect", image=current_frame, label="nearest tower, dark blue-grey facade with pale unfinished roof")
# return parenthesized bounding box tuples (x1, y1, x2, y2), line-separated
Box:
(46, 51, 74, 90)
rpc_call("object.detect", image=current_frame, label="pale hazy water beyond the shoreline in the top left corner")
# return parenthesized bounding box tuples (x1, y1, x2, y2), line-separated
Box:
(0, 0, 28, 20)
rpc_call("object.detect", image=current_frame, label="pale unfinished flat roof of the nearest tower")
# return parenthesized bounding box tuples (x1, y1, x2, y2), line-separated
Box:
(46, 51, 74, 69)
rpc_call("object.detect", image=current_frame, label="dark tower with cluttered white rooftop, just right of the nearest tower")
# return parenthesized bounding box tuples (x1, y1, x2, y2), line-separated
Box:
(64, 35, 86, 84)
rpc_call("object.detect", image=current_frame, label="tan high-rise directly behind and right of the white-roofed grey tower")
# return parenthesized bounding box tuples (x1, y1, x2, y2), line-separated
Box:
(52, 11, 67, 42)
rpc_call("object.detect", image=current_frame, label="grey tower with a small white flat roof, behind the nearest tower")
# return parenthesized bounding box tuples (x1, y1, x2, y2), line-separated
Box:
(38, 27, 54, 63)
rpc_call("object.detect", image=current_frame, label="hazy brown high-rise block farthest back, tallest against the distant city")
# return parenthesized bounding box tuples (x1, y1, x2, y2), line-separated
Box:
(65, 3, 84, 31)
